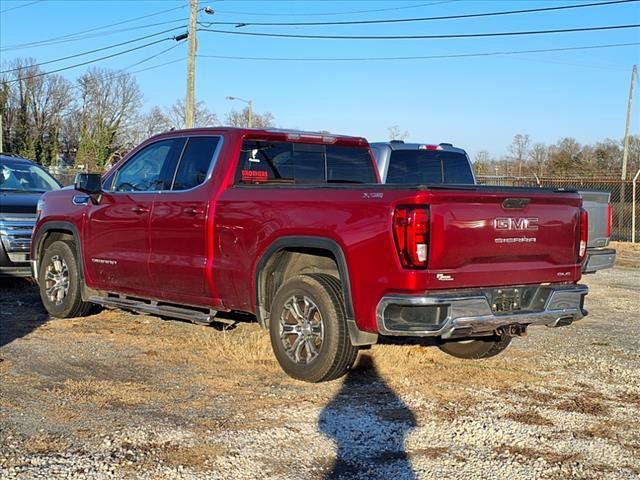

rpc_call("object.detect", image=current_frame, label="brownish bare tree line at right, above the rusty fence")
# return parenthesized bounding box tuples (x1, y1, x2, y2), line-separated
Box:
(473, 134, 640, 178)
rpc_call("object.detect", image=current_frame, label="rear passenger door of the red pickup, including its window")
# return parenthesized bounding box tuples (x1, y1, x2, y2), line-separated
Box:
(149, 136, 222, 303)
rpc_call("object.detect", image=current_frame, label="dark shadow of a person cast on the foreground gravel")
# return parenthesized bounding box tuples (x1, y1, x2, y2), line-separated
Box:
(318, 354, 417, 480)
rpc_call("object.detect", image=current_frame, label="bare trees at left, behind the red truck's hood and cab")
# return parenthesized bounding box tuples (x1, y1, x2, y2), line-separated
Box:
(0, 58, 274, 170)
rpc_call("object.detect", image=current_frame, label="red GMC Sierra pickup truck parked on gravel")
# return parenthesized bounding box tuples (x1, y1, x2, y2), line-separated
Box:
(31, 128, 588, 382)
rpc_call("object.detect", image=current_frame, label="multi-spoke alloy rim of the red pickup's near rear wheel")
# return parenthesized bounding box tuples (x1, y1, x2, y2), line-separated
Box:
(280, 295, 324, 365)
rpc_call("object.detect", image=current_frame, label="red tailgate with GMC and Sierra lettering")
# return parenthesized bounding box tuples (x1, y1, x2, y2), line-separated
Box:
(429, 189, 581, 287)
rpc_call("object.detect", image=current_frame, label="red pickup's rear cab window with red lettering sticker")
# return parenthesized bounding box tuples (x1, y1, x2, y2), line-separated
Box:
(236, 140, 377, 184)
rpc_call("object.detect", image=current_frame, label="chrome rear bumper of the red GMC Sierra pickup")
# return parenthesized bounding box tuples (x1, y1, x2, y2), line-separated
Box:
(376, 285, 588, 339)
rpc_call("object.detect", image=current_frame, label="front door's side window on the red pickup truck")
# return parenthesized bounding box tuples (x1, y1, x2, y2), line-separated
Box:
(111, 138, 184, 192)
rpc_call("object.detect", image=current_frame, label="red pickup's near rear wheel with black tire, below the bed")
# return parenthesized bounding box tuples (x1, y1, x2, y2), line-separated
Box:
(269, 273, 358, 383)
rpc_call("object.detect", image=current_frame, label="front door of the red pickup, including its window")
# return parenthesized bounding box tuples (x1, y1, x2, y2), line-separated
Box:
(84, 138, 184, 296)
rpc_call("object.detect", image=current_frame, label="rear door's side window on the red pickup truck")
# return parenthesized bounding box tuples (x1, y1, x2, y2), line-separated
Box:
(172, 137, 220, 190)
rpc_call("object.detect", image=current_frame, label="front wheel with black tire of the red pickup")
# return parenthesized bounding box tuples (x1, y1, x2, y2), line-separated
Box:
(38, 240, 92, 318)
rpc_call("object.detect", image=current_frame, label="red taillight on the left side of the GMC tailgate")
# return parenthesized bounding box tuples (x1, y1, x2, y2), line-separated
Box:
(393, 206, 429, 268)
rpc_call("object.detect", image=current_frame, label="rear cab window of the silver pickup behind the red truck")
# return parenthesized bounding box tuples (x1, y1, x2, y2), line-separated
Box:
(386, 150, 474, 185)
